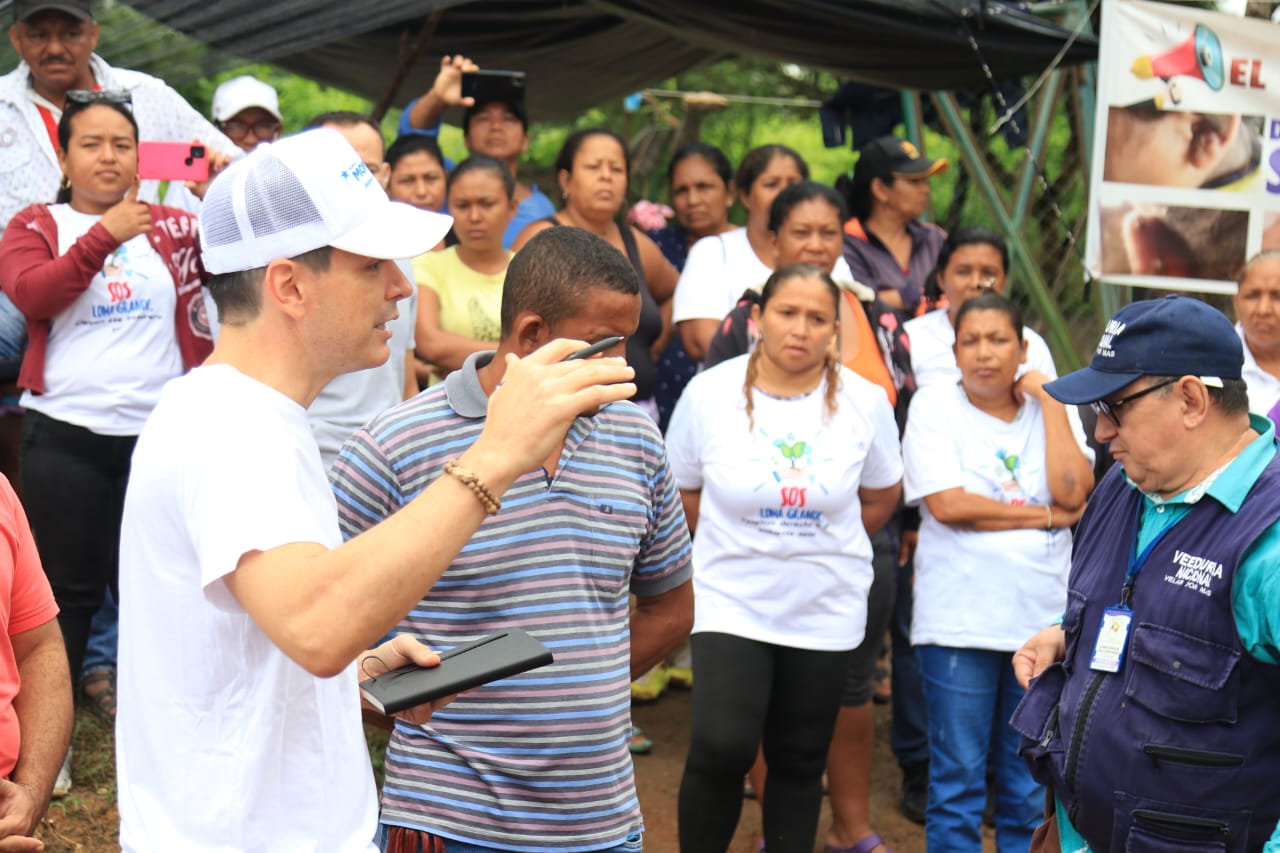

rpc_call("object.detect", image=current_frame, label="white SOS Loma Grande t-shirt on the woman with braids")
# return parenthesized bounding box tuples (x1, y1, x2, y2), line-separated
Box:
(667, 356, 902, 651)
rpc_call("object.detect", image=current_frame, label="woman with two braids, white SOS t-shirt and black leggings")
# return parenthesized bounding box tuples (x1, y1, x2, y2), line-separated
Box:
(667, 264, 902, 853)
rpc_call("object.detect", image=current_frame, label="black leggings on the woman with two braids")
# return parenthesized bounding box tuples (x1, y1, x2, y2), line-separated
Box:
(680, 633, 852, 853)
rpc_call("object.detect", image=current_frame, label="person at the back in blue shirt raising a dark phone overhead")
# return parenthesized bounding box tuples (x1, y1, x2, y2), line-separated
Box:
(399, 55, 556, 248)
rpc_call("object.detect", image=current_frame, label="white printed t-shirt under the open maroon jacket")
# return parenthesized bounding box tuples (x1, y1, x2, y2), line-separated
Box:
(22, 205, 183, 435)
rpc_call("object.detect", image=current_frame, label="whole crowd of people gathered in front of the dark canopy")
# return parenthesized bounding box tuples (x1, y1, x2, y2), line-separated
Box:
(0, 0, 1280, 853)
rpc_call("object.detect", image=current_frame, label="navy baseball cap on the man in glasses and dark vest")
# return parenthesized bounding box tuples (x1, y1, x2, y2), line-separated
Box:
(1044, 296, 1244, 405)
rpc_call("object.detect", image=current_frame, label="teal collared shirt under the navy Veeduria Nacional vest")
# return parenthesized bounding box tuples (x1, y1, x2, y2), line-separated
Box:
(1057, 415, 1280, 853)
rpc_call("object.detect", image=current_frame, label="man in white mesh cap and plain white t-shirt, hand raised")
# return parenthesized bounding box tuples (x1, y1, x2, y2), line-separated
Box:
(116, 129, 635, 850)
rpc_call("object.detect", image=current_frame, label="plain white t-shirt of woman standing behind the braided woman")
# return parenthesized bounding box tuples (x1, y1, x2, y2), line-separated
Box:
(672, 228, 854, 323)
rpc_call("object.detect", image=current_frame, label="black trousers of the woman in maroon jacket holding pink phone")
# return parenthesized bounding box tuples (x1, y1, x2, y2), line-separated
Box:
(20, 410, 138, 678)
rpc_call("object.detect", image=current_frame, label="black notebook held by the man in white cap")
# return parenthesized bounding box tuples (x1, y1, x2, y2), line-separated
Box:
(360, 628, 553, 713)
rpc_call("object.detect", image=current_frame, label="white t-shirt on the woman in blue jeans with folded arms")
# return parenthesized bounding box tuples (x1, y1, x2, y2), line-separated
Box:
(902, 383, 1093, 652)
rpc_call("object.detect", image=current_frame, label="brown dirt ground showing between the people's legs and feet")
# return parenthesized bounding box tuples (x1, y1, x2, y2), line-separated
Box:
(38, 690, 995, 853)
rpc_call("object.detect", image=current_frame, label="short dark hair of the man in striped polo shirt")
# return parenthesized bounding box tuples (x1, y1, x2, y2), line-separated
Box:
(502, 225, 640, 339)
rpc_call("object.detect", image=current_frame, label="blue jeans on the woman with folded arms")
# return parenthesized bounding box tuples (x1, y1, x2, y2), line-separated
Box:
(915, 646, 1044, 853)
